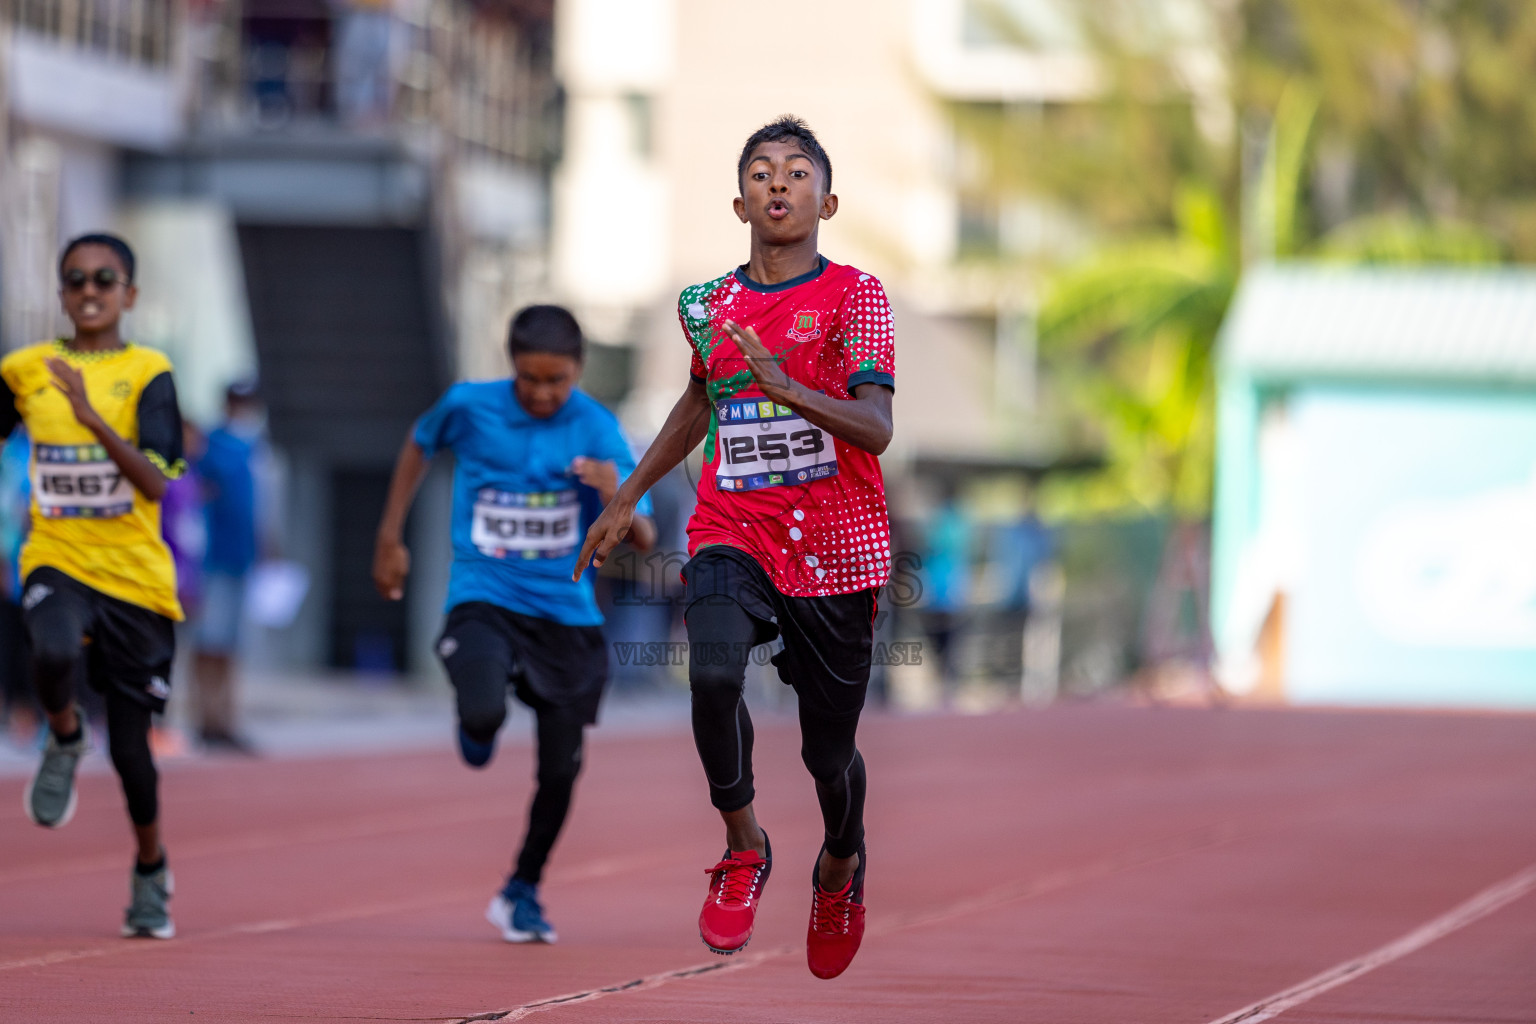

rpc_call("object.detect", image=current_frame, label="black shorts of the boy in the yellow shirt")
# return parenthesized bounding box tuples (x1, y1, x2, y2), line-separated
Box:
(22, 567, 177, 711)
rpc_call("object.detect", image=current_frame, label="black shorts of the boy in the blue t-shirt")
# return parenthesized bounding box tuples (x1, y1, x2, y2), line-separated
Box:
(438, 600, 608, 725)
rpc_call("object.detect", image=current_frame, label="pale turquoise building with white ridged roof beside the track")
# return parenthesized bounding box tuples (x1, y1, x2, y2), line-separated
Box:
(1212, 266, 1536, 708)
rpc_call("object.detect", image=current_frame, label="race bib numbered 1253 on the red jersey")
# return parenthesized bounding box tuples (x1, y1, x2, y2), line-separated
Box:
(714, 398, 837, 491)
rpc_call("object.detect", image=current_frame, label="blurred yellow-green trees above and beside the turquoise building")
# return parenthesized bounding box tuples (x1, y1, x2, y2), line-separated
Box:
(955, 0, 1517, 516)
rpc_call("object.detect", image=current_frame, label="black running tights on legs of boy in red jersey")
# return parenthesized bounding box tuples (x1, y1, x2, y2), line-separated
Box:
(687, 597, 865, 857)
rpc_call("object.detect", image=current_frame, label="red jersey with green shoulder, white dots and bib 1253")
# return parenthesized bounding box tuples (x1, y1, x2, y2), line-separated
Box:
(677, 256, 895, 597)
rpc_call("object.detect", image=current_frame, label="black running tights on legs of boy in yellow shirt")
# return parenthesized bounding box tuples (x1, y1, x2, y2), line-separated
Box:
(28, 602, 160, 827)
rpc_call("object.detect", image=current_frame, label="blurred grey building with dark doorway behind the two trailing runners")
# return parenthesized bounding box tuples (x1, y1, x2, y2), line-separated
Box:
(0, 0, 559, 671)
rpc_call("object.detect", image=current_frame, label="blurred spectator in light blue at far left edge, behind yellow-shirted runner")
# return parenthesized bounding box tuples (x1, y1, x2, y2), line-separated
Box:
(0, 430, 41, 746)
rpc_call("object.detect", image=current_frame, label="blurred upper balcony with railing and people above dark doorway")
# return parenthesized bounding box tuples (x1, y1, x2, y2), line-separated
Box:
(192, 0, 558, 166)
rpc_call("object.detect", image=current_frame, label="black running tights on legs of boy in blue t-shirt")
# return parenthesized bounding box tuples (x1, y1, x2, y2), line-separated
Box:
(452, 659, 585, 884)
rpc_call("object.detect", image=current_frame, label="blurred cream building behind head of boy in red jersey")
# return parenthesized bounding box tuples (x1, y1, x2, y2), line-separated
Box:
(553, 0, 1155, 464)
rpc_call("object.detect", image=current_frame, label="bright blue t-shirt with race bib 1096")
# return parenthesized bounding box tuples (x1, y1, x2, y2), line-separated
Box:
(413, 381, 651, 626)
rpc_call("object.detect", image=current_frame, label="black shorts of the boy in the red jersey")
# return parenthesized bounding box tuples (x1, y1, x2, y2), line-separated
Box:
(682, 543, 880, 718)
